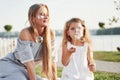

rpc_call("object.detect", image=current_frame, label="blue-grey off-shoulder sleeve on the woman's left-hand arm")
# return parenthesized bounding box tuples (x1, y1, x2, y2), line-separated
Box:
(14, 40, 34, 63)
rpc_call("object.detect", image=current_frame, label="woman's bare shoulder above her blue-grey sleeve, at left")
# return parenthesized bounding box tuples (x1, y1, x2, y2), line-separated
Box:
(19, 28, 31, 40)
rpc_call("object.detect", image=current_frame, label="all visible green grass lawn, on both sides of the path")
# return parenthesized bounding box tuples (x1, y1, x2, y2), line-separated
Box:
(36, 51, 120, 80)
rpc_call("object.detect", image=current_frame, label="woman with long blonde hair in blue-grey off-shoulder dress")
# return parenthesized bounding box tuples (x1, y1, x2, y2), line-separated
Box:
(0, 4, 57, 80)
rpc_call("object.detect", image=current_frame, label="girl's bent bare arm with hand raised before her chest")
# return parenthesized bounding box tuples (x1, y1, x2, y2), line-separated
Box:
(62, 43, 76, 66)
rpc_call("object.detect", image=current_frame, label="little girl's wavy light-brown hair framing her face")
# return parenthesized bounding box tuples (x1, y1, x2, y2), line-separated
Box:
(62, 18, 91, 45)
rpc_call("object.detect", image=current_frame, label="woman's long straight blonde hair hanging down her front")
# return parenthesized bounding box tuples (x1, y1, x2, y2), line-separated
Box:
(28, 4, 52, 80)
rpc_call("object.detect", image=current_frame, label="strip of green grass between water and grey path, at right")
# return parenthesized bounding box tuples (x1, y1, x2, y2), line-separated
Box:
(93, 51, 120, 62)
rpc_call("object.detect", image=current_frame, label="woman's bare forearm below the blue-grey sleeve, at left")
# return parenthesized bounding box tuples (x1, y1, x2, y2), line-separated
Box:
(25, 61, 36, 80)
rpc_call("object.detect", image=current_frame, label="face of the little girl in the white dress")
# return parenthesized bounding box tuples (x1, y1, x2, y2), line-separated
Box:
(67, 22, 84, 40)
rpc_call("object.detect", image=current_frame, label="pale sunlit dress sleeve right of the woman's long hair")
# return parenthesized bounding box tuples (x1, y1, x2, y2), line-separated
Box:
(51, 40, 58, 62)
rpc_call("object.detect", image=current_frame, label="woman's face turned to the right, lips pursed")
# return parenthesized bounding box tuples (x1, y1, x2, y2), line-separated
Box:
(34, 6, 49, 27)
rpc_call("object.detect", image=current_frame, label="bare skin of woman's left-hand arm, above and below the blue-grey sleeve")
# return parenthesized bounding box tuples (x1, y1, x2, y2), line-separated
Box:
(19, 28, 36, 80)
